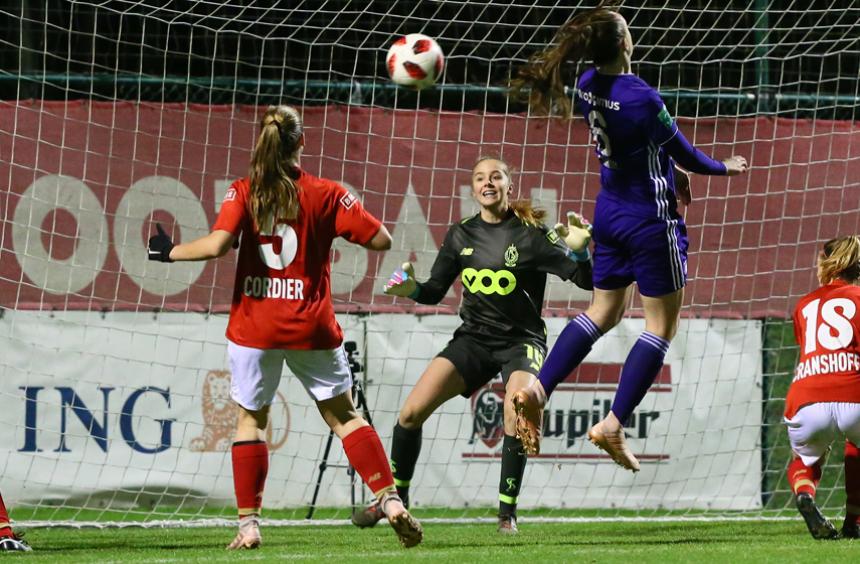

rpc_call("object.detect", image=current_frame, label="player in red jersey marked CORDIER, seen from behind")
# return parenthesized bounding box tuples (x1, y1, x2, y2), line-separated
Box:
(149, 106, 423, 549)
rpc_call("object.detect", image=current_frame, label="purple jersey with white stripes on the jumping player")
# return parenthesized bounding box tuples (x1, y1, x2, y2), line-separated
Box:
(575, 68, 678, 219)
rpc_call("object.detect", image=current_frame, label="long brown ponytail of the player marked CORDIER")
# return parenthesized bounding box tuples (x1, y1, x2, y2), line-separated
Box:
(249, 106, 302, 231)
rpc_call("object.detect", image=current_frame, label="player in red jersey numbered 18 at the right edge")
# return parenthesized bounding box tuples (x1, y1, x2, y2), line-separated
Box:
(785, 235, 860, 539)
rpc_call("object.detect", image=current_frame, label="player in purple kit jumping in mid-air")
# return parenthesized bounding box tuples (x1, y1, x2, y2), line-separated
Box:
(511, 4, 747, 472)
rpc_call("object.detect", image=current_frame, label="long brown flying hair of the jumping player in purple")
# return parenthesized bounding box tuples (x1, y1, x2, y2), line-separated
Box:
(509, 1, 626, 118)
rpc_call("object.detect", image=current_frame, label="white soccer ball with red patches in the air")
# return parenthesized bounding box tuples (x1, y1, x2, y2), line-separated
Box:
(385, 33, 445, 90)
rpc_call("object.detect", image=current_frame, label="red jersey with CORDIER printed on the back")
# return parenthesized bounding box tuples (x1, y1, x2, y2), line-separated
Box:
(212, 170, 382, 350)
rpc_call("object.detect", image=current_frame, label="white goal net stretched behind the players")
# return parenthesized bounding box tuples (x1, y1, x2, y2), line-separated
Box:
(0, 0, 860, 522)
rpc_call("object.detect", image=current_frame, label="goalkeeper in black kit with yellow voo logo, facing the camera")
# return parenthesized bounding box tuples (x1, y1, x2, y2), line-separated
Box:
(353, 157, 591, 533)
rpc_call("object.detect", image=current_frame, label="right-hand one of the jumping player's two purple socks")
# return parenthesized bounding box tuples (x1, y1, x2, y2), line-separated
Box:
(612, 331, 669, 425)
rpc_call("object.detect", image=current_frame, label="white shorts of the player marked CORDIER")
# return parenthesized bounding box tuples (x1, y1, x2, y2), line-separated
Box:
(227, 340, 352, 411)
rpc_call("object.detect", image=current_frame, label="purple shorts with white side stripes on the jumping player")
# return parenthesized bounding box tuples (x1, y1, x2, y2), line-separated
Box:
(593, 198, 688, 297)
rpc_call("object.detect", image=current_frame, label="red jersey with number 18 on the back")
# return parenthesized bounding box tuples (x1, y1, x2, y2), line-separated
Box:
(785, 281, 860, 419)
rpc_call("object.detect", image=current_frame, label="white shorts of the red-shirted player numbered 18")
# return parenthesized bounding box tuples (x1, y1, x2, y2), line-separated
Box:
(785, 402, 860, 466)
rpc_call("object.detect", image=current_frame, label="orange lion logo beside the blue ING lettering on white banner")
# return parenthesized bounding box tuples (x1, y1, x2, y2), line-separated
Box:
(189, 370, 290, 452)
